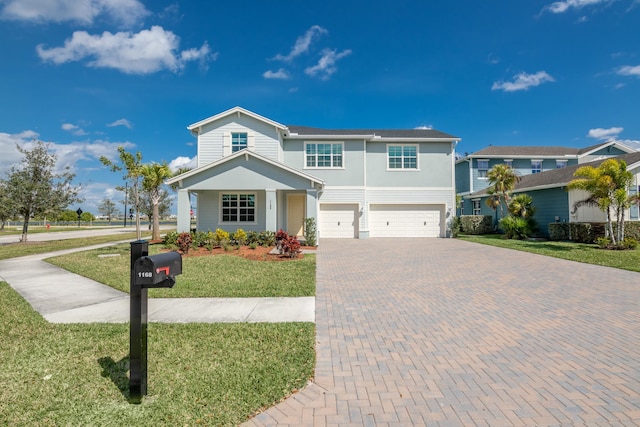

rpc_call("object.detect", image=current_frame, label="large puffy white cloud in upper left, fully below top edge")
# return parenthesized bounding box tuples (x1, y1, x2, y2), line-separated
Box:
(36, 26, 215, 74)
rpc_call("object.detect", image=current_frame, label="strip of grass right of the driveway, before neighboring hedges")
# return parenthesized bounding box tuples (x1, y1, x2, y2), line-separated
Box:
(459, 234, 640, 272)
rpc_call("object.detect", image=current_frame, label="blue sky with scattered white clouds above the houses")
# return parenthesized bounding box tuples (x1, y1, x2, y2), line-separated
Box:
(0, 0, 640, 213)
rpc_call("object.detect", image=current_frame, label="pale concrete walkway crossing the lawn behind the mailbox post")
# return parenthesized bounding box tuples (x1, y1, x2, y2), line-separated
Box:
(0, 241, 315, 323)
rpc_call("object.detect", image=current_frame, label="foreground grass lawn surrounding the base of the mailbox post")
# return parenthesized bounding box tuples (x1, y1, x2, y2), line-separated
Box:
(0, 282, 315, 426)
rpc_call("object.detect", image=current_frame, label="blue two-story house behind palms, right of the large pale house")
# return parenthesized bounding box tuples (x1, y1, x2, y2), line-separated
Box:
(456, 141, 636, 215)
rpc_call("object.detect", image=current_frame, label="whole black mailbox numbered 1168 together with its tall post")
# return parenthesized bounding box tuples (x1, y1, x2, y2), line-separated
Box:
(129, 240, 182, 403)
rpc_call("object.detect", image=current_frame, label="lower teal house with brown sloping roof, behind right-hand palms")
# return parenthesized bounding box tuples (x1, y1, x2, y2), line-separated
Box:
(470, 152, 640, 236)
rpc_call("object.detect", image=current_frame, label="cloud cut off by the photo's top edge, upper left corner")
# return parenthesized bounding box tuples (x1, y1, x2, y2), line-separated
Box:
(0, 0, 149, 27)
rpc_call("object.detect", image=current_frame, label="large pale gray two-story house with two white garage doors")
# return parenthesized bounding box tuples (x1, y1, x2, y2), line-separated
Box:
(168, 107, 459, 238)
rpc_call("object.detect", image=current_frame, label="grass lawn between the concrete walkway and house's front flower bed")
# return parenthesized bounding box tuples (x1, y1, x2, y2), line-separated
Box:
(47, 244, 316, 298)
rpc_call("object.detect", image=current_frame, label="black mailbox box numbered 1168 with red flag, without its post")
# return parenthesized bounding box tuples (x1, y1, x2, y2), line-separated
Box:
(133, 252, 182, 288)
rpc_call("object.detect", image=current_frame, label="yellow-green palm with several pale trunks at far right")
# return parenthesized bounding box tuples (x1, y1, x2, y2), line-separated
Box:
(567, 159, 638, 245)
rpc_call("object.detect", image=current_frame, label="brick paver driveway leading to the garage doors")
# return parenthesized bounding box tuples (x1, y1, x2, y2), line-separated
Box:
(249, 239, 640, 426)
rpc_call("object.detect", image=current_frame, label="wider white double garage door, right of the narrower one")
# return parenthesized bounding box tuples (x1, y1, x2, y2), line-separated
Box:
(369, 205, 442, 237)
